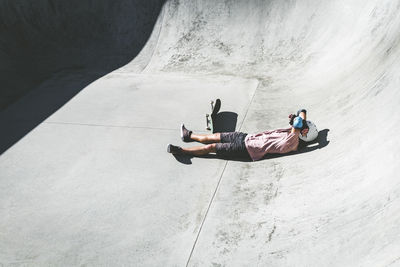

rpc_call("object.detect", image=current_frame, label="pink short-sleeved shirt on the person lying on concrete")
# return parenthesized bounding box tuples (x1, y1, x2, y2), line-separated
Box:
(244, 128, 299, 160)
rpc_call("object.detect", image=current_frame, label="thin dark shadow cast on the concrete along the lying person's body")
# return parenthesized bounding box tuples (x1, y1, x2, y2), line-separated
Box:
(173, 129, 330, 165)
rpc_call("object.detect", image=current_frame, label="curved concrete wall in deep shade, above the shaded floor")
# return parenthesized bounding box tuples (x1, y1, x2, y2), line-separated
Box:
(0, 0, 164, 109)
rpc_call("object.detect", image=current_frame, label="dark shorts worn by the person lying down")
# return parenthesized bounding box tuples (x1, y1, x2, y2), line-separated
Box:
(215, 132, 249, 158)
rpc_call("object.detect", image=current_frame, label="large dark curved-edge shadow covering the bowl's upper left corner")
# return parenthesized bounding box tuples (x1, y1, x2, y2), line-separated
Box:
(0, 0, 166, 155)
